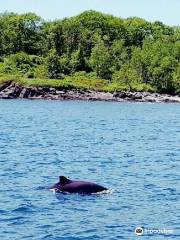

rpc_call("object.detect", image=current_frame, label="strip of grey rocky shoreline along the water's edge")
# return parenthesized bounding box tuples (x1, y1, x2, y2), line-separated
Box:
(0, 82, 180, 103)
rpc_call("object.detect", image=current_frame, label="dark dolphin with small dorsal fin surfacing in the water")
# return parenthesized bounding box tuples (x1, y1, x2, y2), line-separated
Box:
(48, 176, 107, 194)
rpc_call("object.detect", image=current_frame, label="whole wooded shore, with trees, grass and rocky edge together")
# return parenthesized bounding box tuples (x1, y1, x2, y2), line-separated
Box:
(0, 11, 180, 99)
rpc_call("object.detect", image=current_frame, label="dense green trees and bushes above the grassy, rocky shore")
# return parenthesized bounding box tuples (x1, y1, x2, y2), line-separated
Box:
(0, 11, 180, 94)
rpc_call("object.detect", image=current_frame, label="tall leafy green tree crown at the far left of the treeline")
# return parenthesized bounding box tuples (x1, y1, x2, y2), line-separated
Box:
(0, 13, 44, 55)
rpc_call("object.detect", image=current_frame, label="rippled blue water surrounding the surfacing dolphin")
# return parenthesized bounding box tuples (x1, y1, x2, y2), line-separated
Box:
(0, 100, 180, 240)
